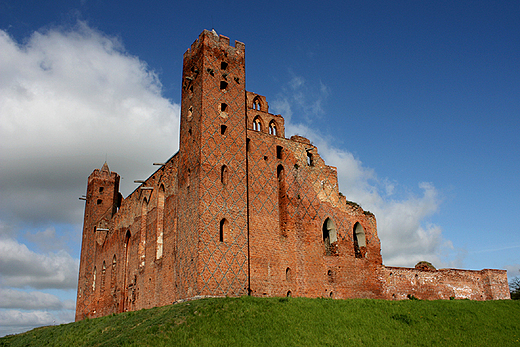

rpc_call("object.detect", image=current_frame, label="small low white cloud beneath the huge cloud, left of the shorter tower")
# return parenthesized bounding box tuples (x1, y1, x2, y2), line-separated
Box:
(0, 238, 79, 289)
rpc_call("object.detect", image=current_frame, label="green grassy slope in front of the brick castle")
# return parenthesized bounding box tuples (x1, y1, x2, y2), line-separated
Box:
(0, 297, 520, 347)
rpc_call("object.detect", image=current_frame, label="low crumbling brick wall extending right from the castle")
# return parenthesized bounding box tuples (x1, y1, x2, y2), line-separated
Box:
(381, 266, 511, 300)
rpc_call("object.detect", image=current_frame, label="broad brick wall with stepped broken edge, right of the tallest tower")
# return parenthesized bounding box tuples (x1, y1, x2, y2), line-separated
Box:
(247, 115, 381, 298)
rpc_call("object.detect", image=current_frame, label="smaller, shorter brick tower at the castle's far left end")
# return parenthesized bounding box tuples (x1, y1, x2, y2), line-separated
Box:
(77, 163, 121, 318)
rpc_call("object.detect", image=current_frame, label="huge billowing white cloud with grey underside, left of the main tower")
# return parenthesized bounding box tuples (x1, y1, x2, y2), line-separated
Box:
(0, 23, 179, 227)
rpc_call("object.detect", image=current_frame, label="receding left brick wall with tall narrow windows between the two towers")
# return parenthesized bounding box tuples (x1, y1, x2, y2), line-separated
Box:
(76, 157, 181, 320)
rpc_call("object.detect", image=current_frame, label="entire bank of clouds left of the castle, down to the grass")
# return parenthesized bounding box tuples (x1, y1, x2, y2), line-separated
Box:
(0, 22, 180, 335)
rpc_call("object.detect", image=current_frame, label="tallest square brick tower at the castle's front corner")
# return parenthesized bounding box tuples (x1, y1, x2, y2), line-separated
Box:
(176, 30, 248, 297)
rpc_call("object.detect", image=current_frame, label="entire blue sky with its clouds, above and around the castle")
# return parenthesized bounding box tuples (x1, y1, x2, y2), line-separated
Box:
(0, 0, 520, 335)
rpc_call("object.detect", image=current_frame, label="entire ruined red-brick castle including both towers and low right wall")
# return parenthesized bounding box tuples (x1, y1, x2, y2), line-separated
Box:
(76, 30, 509, 320)
